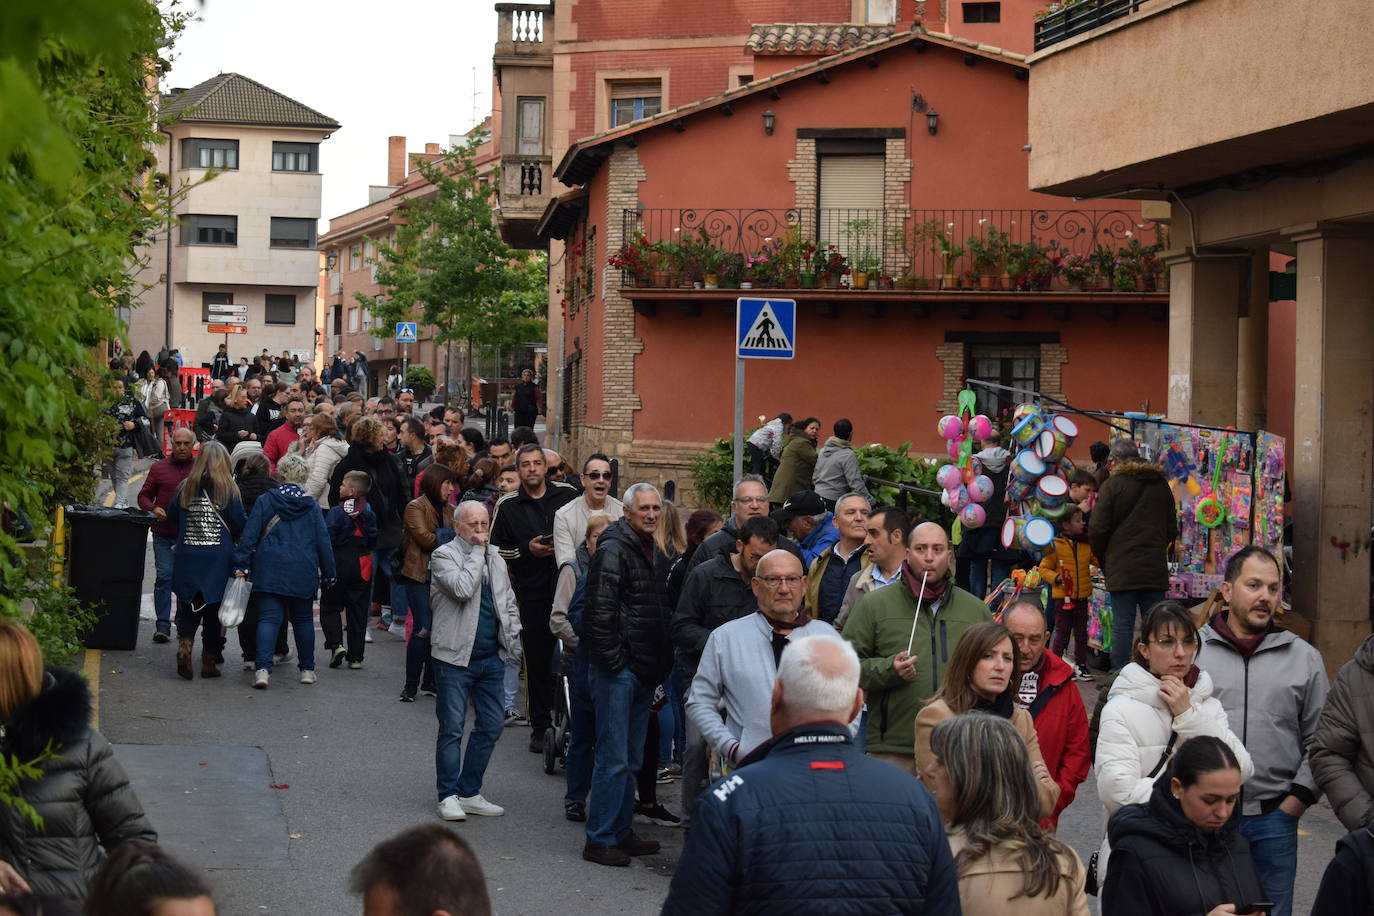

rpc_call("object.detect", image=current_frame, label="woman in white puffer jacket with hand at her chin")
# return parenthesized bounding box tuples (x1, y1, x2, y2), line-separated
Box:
(1094, 600, 1254, 887)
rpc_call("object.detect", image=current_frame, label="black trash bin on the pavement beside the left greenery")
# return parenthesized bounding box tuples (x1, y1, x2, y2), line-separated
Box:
(66, 505, 157, 651)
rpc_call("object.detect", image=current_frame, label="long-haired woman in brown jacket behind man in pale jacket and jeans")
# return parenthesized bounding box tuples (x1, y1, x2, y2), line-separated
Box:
(396, 464, 453, 703)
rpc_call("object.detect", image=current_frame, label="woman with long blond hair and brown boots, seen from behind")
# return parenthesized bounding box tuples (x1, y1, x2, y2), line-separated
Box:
(168, 442, 245, 680)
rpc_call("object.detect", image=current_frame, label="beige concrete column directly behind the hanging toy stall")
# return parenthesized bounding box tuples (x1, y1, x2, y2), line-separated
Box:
(1165, 251, 1250, 426)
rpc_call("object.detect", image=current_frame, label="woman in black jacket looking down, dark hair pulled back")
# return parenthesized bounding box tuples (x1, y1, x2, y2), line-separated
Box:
(1102, 735, 1264, 916)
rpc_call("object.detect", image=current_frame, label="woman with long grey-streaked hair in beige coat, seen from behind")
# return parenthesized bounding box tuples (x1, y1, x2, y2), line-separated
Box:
(923, 713, 1088, 916)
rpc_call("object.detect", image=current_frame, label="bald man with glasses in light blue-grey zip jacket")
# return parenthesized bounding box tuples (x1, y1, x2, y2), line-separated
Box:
(687, 548, 840, 769)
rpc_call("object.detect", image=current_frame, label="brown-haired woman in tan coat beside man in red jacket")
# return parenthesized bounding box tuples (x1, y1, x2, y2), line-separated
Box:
(916, 621, 1059, 817)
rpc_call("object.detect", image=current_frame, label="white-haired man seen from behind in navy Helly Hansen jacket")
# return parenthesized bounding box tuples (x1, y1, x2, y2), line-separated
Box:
(662, 637, 959, 916)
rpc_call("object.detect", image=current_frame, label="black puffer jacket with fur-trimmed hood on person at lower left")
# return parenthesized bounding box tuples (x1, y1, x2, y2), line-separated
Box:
(0, 661, 158, 901)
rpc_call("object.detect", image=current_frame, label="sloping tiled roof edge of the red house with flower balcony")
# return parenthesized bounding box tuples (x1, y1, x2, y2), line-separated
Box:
(554, 25, 1029, 187)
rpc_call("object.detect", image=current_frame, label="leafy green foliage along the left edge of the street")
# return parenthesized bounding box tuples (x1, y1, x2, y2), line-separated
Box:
(0, 0, 184, 631)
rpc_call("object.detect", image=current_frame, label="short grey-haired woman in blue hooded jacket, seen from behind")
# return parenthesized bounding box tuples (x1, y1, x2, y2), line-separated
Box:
(234, 455, 334, 689)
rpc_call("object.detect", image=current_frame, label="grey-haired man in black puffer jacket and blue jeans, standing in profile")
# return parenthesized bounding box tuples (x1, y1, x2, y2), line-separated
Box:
(583, 483, 673, 865)
